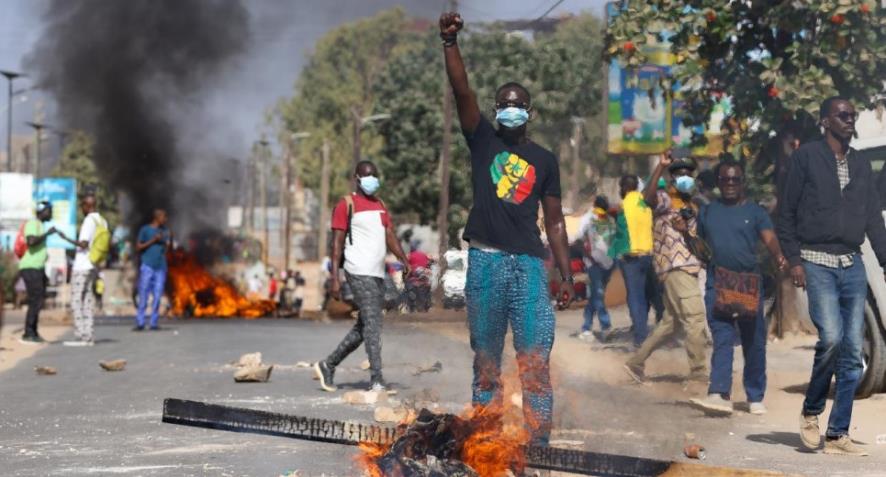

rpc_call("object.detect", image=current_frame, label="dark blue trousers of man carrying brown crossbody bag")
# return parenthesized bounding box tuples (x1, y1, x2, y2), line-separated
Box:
(704, 268, 766, 402)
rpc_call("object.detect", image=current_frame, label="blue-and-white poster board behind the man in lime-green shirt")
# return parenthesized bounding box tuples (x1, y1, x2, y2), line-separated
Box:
(31, 177, 77, 250)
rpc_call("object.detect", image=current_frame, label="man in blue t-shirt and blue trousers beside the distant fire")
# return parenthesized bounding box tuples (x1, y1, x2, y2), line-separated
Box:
(133, 208, 172, 331)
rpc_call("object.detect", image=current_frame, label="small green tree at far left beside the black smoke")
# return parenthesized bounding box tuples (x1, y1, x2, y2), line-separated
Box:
(52, 131, 120, 226)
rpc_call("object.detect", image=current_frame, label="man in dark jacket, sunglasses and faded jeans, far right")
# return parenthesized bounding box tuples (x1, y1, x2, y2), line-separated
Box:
(777, 97, 886, 456)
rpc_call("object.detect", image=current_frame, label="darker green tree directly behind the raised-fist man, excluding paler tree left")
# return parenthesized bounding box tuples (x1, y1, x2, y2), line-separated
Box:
(375, 15, 604, 245)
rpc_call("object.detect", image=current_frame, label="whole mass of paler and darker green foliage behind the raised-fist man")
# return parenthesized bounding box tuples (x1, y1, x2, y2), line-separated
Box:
(278, 9, 604, 245)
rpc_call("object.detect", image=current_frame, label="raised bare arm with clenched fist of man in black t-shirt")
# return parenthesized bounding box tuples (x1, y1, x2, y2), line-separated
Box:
(440, 12, 480, 134)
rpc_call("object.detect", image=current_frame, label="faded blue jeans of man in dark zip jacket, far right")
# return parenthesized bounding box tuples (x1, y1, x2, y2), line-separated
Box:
(803, 255, 868, 437)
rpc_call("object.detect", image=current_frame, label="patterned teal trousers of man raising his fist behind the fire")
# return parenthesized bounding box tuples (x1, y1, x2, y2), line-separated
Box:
(465, 248, 555, 445)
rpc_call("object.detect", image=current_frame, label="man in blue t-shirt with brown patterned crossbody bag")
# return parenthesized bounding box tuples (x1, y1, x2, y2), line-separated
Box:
(690, 160, 787, 415)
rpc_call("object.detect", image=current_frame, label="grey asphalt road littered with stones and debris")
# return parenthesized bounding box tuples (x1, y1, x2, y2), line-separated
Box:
(0, 312, 886, 477)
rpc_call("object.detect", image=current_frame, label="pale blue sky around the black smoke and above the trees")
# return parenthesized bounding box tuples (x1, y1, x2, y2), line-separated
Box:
(0, 0, 605, 161)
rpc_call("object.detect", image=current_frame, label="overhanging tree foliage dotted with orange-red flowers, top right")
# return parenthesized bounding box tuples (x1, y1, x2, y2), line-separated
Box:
(606, 0, 886, 192)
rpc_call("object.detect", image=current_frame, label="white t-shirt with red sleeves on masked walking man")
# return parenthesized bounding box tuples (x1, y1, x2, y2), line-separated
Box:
(332, 192, 392, 278)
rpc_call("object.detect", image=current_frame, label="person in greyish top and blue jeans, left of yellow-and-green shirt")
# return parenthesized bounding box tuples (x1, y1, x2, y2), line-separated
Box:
(579, 195, 615, 341)
